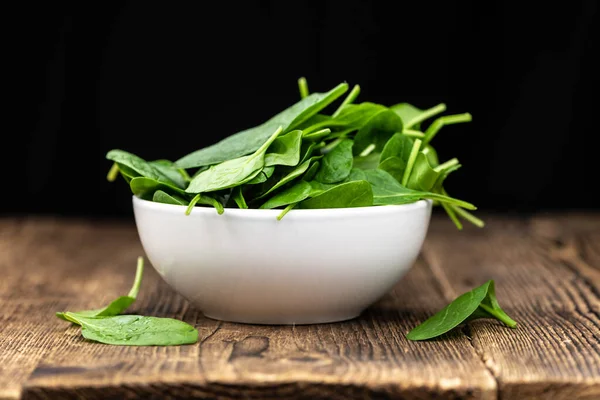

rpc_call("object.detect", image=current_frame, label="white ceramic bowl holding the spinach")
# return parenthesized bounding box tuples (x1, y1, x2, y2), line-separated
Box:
(133, 196, 431, 324)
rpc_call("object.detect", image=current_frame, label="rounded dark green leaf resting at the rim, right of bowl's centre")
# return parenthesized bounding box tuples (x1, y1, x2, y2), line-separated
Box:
(300, 180, 373, 208)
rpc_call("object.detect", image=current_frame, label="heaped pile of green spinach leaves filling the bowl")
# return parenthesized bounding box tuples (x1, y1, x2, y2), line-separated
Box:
(106, 78, 483, 229)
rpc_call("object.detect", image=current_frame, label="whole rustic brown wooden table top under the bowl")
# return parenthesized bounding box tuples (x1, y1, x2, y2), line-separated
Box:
(0, 214, 600, 400)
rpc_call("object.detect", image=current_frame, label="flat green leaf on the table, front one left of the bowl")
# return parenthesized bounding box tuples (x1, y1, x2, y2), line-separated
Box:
(64, 312, 198, 346)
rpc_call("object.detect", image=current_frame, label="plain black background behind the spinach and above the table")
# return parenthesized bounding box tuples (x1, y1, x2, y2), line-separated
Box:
(7, 0, 600, 217)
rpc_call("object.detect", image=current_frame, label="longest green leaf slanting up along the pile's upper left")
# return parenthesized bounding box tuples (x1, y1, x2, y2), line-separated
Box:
(175, 83, 348, 168)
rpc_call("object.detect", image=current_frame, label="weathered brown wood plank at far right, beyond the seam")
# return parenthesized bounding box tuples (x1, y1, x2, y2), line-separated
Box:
(424, 217, 600, 399)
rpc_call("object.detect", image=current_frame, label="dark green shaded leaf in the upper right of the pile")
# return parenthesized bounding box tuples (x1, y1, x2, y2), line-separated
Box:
(353, 106, 402, 155)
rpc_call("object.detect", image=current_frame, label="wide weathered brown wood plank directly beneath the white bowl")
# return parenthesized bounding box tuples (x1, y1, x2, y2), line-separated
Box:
(0, 219, 496, 399)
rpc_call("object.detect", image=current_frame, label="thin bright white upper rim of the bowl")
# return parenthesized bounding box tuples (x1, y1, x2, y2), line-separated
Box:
(132, 195, 433, 219)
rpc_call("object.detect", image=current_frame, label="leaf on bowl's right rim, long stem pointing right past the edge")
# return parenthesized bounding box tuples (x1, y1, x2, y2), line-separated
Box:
(365, 169, 476, 210)
